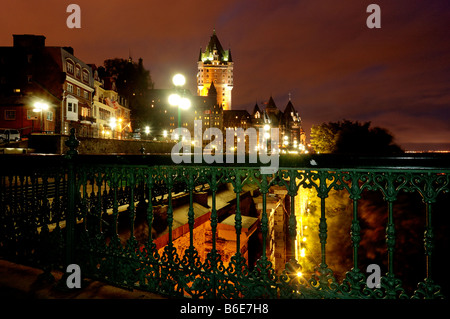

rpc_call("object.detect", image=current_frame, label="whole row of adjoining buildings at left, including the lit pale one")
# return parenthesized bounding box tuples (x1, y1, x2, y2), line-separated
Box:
(0, 34, 131, 142)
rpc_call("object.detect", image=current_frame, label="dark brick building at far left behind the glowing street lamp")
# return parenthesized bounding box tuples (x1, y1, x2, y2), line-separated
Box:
(0, 34, 94, 135)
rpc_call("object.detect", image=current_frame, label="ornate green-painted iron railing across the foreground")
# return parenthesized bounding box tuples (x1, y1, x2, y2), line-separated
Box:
(0, 131, 450, 299)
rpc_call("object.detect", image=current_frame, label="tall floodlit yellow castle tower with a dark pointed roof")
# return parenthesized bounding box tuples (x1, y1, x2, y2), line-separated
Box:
(197, 30, 233, 110)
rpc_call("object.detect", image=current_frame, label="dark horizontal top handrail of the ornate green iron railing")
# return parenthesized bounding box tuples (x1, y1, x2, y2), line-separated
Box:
(0, 153, 450, 173)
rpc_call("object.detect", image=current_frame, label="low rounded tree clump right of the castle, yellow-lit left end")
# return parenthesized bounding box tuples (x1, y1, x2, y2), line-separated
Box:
(311, 120, 403, 155)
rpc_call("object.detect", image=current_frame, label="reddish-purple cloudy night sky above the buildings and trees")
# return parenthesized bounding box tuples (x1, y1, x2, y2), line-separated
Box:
(0, 0, 450, 150)
